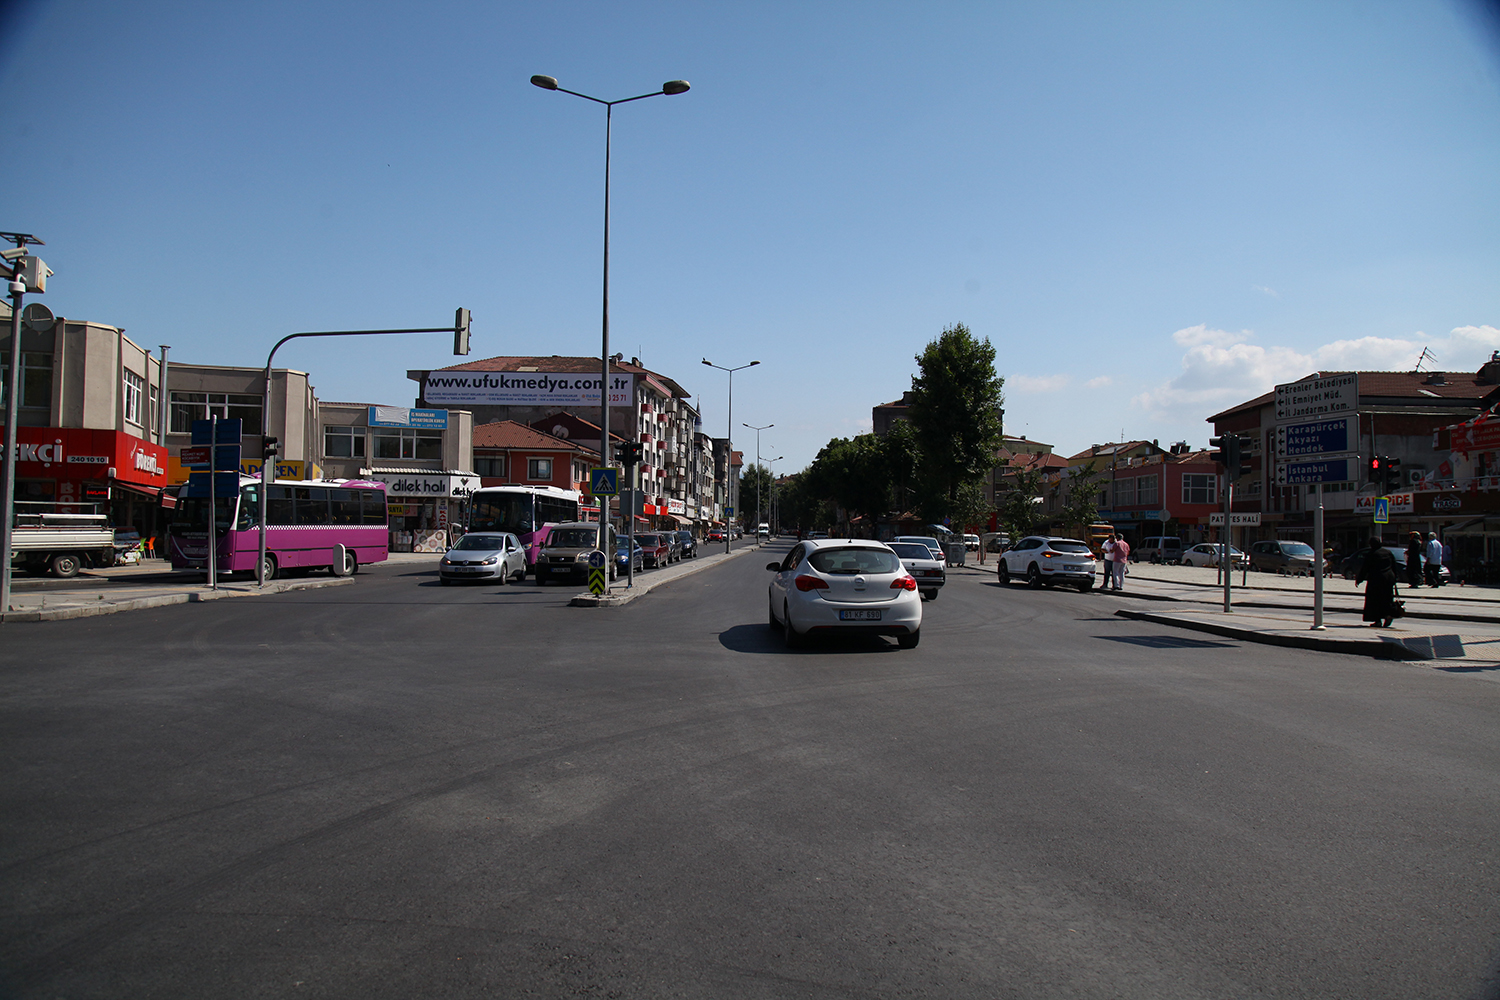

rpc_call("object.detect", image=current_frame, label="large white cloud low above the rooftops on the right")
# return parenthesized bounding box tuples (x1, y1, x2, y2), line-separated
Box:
(1131, 324, 1500, 421)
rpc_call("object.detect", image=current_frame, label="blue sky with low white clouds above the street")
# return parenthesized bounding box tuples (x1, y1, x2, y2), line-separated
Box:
(0, 0, 1500, 471)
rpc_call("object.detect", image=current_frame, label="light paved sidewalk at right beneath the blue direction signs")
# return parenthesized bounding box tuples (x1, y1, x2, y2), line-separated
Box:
(950, 561, 1500, 670)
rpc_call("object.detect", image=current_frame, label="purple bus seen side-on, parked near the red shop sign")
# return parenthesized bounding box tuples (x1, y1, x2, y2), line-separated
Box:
(167, 477, 390, 580)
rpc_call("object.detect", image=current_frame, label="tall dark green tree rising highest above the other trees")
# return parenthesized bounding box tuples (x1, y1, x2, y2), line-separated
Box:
(908, 322, 1005, 522)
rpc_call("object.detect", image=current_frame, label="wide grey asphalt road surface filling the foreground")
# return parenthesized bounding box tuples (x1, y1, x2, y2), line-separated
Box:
(0, 544, 1500, 1000)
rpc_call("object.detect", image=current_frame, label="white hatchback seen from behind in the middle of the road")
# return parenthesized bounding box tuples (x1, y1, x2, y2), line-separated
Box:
(765, 538, 923, 649)
